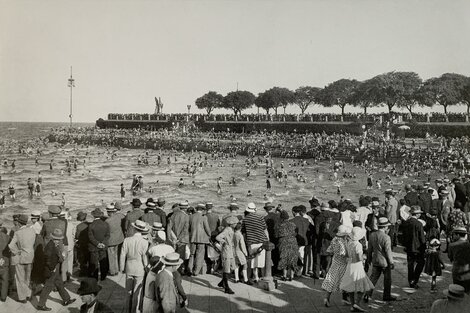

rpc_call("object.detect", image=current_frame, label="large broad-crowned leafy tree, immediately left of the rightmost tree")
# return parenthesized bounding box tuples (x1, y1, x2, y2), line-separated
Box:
(372, 72, 422, 113)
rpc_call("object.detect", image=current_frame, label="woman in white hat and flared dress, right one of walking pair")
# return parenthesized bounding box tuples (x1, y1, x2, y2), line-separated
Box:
(339, 227, 374, 312)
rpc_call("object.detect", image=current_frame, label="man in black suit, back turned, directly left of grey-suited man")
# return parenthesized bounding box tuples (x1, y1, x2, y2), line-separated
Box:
(88, 208, 110, 280)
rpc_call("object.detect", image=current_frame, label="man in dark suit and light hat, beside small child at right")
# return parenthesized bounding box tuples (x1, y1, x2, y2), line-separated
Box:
(403, 205, 426, 288)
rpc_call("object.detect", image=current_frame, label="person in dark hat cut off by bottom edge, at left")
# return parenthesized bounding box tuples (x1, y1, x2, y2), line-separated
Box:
(77, 277, 113, 313)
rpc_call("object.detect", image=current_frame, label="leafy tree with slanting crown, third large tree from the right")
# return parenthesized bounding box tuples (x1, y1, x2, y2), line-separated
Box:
(317, 78, 357, 118)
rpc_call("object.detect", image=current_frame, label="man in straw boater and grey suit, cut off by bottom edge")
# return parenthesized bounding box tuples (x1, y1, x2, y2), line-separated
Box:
(155, 253, 183, 313)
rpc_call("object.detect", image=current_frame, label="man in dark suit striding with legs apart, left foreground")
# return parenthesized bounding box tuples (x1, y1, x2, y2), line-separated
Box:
(37, 228, 76, 311)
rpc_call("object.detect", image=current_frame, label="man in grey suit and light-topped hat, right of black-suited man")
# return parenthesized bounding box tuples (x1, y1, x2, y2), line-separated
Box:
(106, 205, 124, 276)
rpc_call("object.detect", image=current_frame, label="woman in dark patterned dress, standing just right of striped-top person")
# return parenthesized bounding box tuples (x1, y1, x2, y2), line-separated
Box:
(277, 210, 299, 281)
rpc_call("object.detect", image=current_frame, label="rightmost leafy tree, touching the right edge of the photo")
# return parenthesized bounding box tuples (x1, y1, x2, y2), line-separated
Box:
(423, 73, 467, 116)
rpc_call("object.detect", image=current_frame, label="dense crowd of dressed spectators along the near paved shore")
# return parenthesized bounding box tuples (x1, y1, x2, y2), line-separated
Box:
(0, 175, 470, 313)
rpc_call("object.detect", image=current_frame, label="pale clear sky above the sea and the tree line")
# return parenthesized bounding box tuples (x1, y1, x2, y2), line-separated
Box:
(0, 0, 470, 122)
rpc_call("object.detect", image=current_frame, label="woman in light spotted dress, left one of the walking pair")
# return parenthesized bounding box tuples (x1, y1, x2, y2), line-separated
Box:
(321, 225, 350, 307)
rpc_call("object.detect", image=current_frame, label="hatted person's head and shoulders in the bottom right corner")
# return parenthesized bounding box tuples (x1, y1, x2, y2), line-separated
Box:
(430, 284, 470, 313)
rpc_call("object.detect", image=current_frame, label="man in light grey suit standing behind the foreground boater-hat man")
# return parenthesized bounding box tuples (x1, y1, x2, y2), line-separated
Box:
(167, 201, 190, 274)
